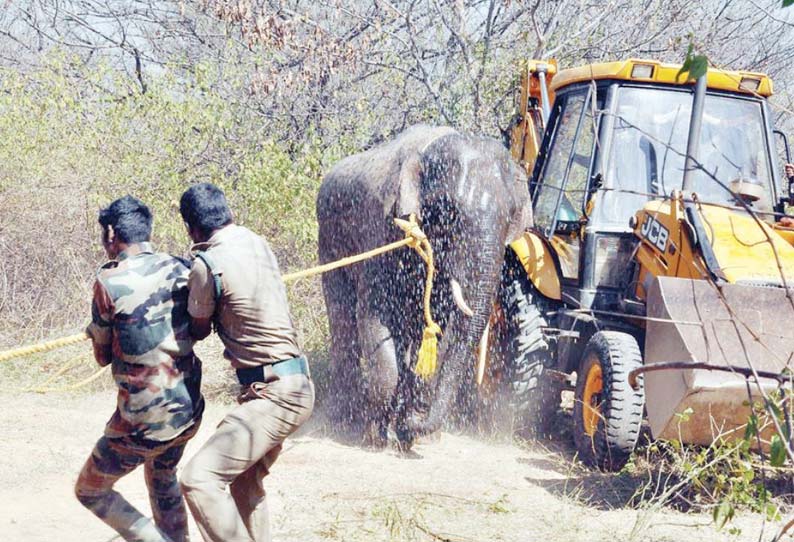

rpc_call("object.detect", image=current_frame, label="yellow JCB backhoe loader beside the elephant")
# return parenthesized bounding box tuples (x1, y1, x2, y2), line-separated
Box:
(492, 59, 794, 469)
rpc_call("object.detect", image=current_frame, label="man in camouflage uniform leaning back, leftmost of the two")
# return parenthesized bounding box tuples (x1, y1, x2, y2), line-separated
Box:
(75, 196, 204, 542)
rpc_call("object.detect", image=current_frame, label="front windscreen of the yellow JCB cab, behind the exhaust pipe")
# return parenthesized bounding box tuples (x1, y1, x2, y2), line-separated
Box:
(596, 86, 773, 229)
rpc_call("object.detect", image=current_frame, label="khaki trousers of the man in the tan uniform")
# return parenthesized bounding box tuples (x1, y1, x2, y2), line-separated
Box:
(180, 374, 314, 542)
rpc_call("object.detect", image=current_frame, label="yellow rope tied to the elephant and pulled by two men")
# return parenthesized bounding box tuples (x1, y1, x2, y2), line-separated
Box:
(0, 214, 441, 392)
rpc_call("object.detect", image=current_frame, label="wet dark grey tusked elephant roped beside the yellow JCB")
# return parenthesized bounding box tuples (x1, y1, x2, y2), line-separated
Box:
(317, 125, 532, 448)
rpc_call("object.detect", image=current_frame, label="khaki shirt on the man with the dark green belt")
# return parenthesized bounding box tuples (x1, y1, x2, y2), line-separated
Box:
(188, 224, 302, 369)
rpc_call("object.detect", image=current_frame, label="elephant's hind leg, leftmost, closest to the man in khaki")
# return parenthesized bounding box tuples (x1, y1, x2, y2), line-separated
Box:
(323, 269, 366, 431)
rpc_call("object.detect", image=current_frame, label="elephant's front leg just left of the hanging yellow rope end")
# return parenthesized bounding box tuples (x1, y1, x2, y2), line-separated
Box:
(357, 297, 399, 447)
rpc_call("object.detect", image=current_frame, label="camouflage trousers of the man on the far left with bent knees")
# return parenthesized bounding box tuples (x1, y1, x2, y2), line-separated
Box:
(75, 420, 199, 542)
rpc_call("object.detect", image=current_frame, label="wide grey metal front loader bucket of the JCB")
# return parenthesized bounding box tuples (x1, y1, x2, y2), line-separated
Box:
(644, 277, 794, 445)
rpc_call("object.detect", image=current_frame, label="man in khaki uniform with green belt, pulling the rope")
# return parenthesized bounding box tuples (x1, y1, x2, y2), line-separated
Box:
(180, 183, 314, 542)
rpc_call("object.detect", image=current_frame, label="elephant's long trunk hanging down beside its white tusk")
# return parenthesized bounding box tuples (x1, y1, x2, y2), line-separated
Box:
(408, 235, 504, 436)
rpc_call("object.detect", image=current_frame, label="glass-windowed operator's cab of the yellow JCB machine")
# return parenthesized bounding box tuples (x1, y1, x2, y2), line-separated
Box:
(532, 61, 781, 304)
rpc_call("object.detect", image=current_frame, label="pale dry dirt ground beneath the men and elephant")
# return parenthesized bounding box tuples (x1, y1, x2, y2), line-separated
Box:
(0, 391, 778, 542)
